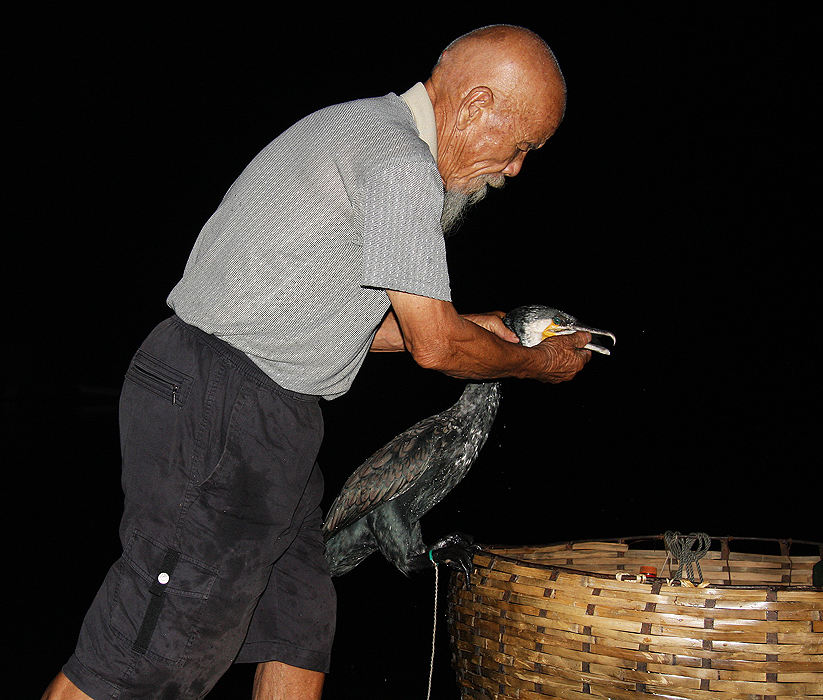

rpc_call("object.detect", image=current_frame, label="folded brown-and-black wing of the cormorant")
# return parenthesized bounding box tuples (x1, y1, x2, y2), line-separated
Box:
(323, 412, 451, 540)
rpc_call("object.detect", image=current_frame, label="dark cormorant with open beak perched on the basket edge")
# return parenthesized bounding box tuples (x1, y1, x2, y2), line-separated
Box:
(323, 305, 615, 576)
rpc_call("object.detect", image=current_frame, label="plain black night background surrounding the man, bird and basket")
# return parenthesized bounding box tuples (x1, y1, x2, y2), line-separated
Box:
(9, 2, 821, 700)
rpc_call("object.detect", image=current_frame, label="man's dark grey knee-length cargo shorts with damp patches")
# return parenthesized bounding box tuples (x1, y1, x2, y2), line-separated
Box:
(63, 317, 335, 700)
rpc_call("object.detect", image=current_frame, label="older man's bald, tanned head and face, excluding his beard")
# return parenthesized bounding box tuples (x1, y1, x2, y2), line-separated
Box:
(426, 25, 566, 197)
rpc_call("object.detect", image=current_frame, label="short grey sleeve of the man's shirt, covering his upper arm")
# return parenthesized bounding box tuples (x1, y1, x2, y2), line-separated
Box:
(362, 162, 451, 301)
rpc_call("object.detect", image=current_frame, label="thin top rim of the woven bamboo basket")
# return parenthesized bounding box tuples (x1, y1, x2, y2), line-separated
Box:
(475, 535, 823, 591)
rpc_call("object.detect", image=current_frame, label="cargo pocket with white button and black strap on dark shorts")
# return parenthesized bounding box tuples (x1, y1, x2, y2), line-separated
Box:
(111, 531, 217, 666)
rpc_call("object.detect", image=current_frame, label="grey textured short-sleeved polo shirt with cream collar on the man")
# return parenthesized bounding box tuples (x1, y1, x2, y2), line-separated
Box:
(168, 84, 451, 399)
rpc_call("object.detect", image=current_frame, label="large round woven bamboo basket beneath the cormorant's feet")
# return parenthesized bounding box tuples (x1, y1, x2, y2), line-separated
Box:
(449, 536, 823, 700)
